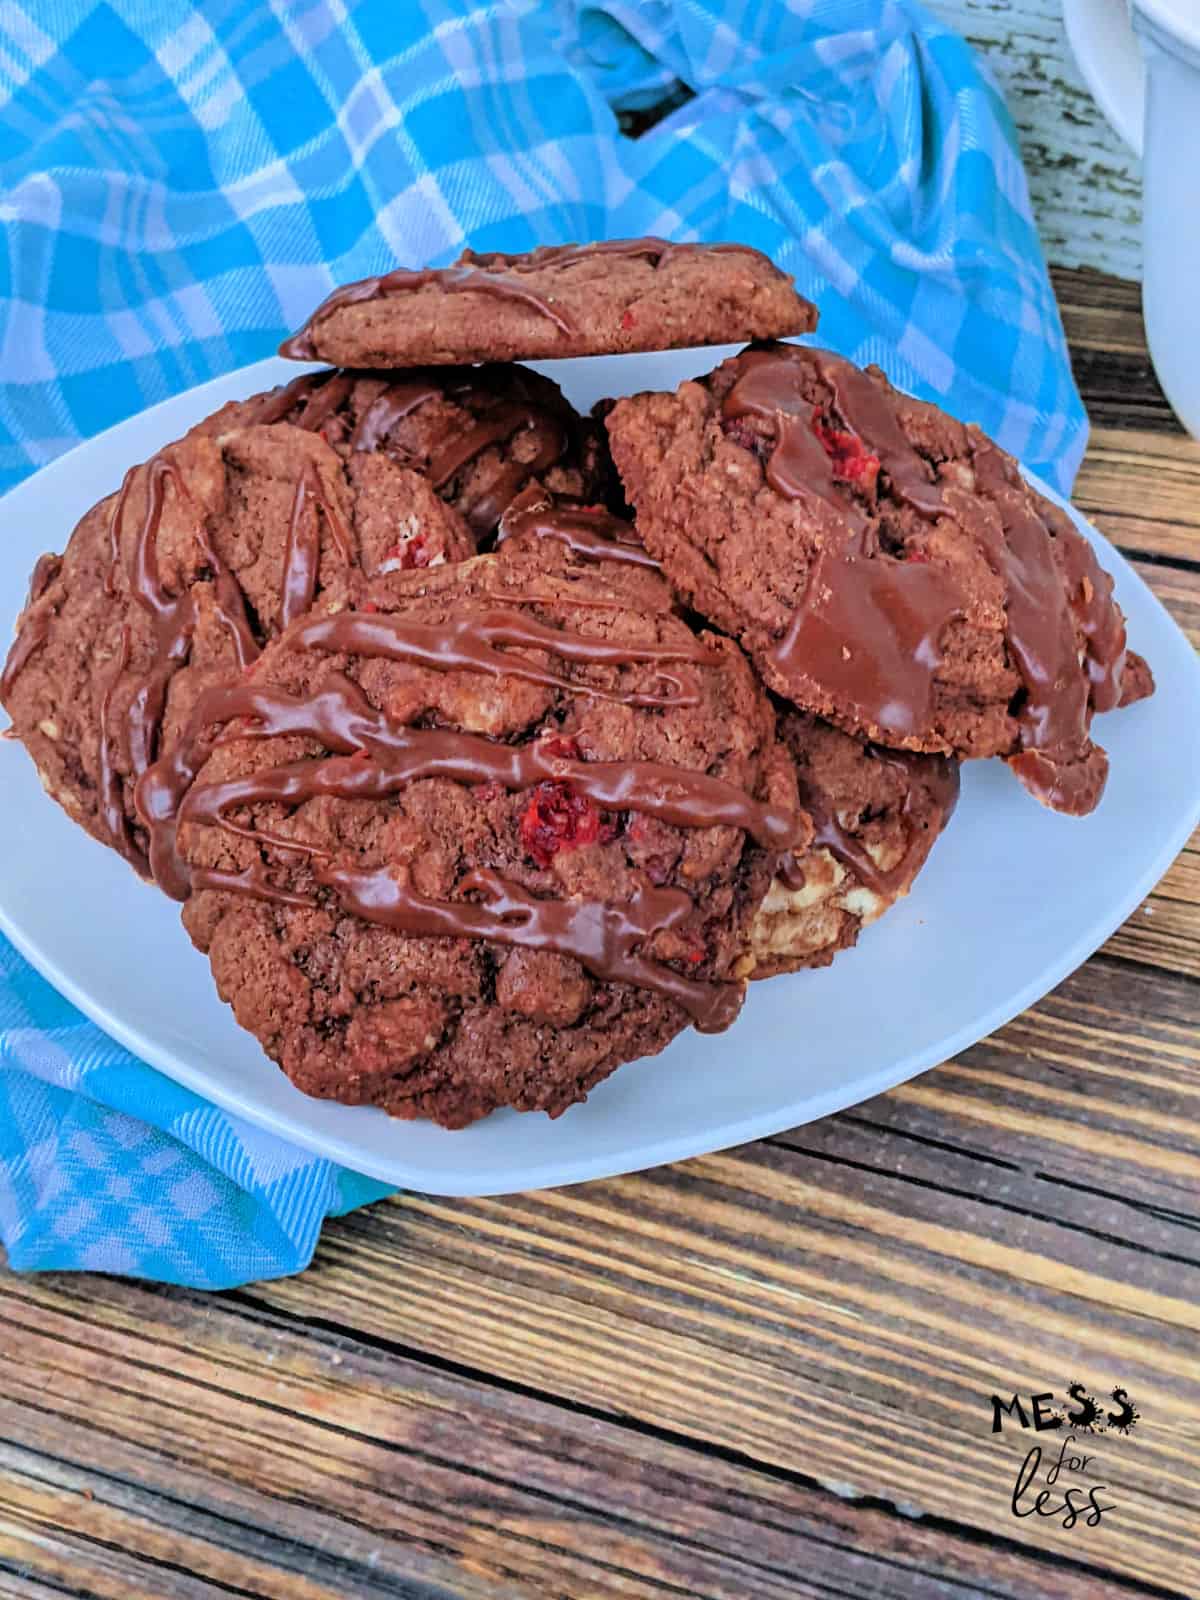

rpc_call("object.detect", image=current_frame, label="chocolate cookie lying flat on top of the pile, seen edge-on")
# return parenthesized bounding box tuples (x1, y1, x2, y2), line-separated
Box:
(280, 238, 816, 366)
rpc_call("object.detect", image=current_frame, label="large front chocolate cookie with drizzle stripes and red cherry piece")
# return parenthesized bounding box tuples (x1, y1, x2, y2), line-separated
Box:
(150, 550, 808, 1126)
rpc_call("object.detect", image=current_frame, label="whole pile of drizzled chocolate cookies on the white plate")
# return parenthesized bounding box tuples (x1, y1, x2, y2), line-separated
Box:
(0, 238, 1152, 1128)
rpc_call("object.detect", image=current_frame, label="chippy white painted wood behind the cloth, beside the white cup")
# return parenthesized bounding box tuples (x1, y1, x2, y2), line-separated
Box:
(928, 0, 1141, 278)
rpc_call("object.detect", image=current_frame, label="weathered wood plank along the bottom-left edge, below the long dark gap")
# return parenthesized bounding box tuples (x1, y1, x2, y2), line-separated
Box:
(0, 1277, 1158, 1600)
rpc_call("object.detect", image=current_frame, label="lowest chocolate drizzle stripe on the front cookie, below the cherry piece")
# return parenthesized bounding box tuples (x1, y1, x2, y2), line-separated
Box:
(315, 866, 742, 1034)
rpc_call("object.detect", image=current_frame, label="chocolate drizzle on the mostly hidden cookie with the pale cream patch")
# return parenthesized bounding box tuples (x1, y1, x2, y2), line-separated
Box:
(778, 744, 958, 901)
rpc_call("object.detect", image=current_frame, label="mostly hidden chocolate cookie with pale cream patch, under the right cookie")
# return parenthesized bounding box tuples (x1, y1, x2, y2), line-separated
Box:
(750, 710, 958, 978)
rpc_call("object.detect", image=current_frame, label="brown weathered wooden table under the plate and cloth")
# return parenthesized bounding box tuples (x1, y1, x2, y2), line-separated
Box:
(0, 272, 1200, 1600)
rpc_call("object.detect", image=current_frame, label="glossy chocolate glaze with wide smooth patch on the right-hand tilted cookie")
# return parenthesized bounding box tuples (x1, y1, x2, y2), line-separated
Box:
(723, 344, 1125, 811)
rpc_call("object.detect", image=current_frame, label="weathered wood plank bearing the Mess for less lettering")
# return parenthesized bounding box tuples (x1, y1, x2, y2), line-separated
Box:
(227, 963, 1200, 1590)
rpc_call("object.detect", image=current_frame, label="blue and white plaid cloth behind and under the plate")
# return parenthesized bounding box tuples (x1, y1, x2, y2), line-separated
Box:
(0, 0, 1086, 1288)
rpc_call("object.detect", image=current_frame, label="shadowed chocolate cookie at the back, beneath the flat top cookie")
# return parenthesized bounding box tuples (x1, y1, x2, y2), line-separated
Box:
(227, 365, 614, 544)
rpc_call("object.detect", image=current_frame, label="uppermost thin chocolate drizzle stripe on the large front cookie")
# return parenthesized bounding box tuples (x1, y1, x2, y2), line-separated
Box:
(291, 600, 710, 706)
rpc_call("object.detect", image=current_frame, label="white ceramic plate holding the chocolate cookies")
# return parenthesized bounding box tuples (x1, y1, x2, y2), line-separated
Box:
(0, 360, 1200, 1194)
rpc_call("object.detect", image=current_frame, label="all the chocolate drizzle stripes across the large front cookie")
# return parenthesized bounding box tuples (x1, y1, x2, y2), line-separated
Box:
(138, 595, 793, 1029)
